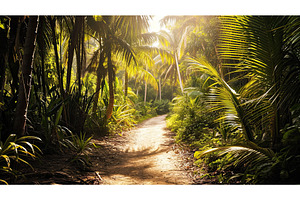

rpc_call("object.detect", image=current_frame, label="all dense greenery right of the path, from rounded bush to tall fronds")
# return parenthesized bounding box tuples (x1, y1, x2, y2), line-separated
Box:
(168, 16, 300, 184)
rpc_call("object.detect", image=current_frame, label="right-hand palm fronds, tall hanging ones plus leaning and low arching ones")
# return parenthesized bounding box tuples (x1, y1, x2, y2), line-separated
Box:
(190, 16, 300, 183)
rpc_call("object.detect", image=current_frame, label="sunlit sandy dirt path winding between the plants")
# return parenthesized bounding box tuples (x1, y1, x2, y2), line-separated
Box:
(91, 115, 192, 185)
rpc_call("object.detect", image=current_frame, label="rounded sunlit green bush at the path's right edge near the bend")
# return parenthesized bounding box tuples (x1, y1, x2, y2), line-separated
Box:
(167, 86, 216, 147)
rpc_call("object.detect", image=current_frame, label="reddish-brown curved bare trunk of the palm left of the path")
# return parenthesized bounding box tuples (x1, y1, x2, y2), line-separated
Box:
(106, 51, 115, 119)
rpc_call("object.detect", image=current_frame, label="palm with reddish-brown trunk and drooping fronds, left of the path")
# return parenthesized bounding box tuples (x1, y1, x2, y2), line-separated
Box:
(88, 16, 148, 119)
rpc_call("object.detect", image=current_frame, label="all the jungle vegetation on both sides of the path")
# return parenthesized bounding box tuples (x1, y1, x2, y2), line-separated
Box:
(0, 16, 300, 184)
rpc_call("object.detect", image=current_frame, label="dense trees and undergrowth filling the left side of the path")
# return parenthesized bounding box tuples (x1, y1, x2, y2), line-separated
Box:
(0, 16, 170, 184)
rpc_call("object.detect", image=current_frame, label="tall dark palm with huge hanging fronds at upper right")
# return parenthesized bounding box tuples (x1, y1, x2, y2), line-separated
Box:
(220, 16, 299, 149)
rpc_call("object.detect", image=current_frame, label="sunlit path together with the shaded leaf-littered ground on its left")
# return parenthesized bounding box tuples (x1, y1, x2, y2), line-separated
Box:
(15, 115, 204, 185)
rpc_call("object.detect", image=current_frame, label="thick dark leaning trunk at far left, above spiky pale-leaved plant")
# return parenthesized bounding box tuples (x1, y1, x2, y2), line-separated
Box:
(13, 16, 39, 136)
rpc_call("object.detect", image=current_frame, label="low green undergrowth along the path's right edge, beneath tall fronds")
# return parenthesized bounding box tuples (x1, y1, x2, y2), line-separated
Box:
(167, 80, 300, 184)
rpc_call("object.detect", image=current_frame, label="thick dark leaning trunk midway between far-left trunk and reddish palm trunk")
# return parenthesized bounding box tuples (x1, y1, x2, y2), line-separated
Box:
(66, 16, 83, 93)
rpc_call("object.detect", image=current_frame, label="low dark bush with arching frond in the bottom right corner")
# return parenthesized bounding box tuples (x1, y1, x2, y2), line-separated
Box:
(195, 103, 300, 184)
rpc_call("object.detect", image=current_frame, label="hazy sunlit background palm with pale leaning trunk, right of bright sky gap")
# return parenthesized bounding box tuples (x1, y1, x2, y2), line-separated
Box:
(161, 16, 223, 93)
